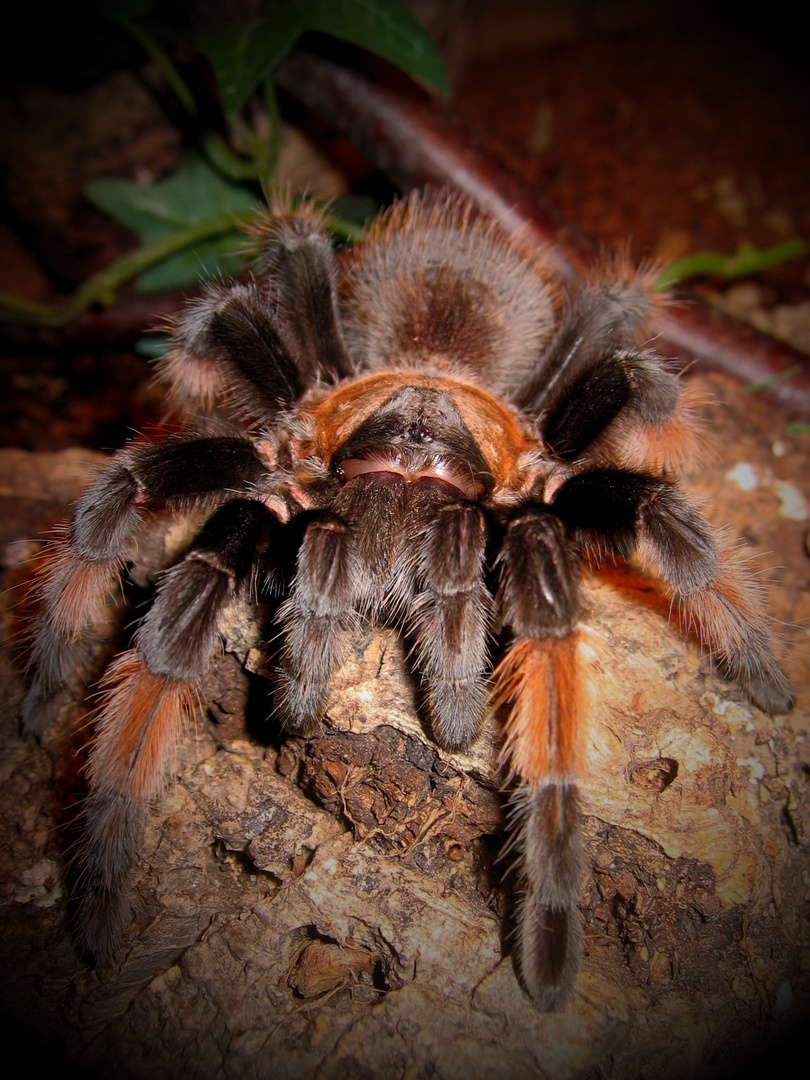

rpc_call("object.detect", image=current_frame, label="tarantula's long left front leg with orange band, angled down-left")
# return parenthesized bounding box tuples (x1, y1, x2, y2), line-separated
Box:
(75, 499, 281, 959)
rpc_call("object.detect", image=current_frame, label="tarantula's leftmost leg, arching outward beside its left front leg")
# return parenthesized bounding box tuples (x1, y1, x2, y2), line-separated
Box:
(22, 437, 265, 732)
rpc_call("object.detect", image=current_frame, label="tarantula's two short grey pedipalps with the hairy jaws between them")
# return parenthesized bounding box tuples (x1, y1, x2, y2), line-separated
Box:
(276, 472, 492, 748)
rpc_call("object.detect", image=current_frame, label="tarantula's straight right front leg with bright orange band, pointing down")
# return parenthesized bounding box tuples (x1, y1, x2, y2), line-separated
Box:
(492, 504, 590, 1010)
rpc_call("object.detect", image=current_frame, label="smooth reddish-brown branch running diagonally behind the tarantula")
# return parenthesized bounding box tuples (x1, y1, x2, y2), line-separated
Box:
(276, 53, 810, 418)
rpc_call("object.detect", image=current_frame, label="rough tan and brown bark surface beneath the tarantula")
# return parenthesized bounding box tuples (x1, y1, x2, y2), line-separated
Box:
(0, 377, 810, 1080)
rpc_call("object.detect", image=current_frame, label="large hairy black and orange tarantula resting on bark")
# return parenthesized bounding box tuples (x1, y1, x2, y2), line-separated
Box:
(24, 193, 793, 1009)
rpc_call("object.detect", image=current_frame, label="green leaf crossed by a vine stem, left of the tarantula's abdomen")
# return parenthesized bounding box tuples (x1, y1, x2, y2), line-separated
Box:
(84, 154, 257, 293)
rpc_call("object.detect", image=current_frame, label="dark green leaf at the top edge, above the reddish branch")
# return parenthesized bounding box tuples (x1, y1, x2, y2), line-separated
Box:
(199, 0, 448, 120)
